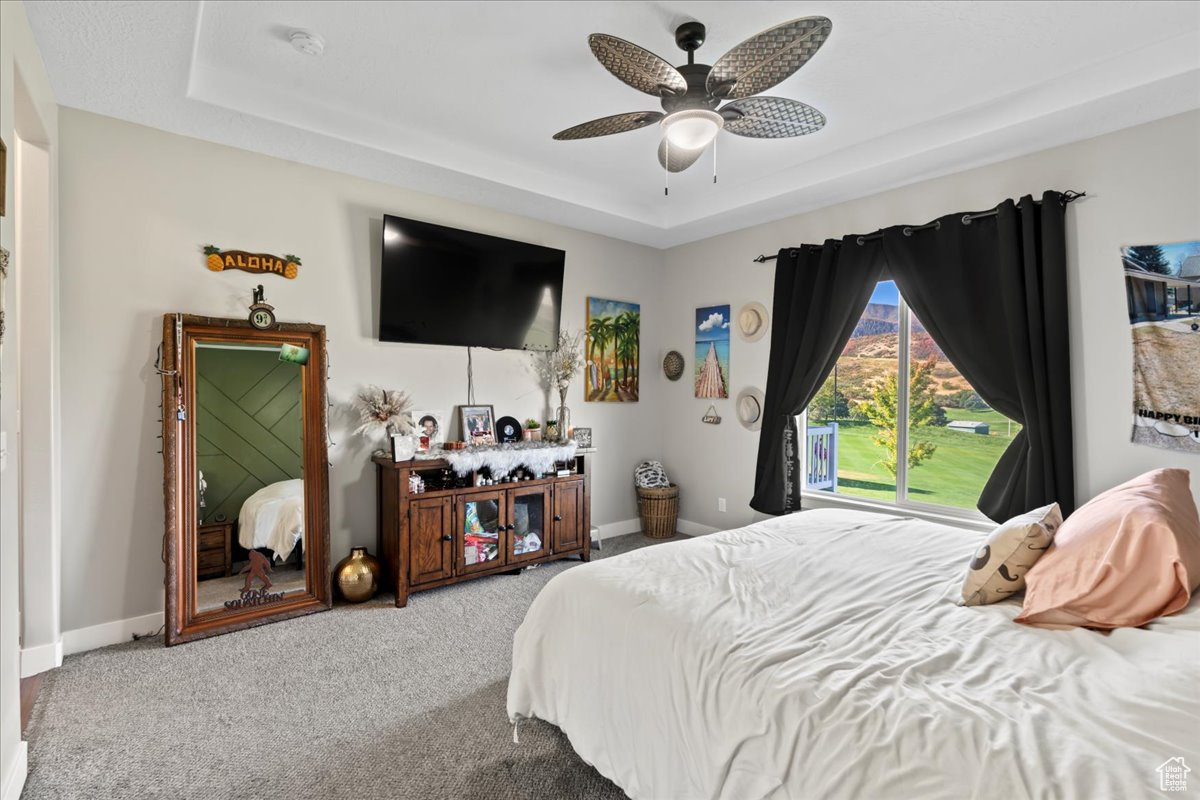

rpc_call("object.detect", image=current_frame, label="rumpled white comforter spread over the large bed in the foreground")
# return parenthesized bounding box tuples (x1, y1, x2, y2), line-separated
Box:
(508, 511, 1200, 800)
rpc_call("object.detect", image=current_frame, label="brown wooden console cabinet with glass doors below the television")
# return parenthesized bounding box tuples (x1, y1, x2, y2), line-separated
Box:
(373, 455, 592, 608)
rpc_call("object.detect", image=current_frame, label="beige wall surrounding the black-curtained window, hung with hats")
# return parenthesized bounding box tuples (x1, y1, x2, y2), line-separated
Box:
(662, 112, 1200, 528)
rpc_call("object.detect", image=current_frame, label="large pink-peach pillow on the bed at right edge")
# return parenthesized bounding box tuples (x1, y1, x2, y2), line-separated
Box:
(1016, 469, 1200, 628)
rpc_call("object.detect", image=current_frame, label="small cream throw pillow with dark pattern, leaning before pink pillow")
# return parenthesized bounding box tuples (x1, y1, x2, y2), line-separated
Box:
(962, 503, 1062, 606)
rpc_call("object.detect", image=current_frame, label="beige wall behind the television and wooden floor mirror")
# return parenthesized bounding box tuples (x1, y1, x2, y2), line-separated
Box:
(60, 109, 665, 633)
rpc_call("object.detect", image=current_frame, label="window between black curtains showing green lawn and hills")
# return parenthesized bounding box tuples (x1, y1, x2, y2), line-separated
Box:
(804, 281, 1020, 510)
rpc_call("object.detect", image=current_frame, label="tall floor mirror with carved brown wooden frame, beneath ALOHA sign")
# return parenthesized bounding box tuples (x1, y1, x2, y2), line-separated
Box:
(158, 314, 331, 646)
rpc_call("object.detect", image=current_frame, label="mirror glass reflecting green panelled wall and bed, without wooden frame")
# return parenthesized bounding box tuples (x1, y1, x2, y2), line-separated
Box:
(194, 342, 307, 614)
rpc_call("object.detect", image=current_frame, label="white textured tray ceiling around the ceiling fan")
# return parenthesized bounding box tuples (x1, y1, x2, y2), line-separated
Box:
(25, 0, 1200, 247)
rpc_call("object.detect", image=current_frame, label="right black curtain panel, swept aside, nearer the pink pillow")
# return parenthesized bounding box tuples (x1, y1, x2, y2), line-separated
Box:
(883, 192, 1075, 522)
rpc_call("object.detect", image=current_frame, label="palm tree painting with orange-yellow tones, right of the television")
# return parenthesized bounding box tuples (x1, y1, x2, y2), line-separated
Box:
(583, 297, 642, 403)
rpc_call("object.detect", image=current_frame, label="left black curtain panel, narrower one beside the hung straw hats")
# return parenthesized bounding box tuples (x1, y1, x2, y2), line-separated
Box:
(750, 236, 883, 515)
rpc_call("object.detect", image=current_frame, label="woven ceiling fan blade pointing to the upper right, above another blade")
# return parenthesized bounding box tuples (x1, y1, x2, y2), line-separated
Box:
(706, 17, 833, 100)
